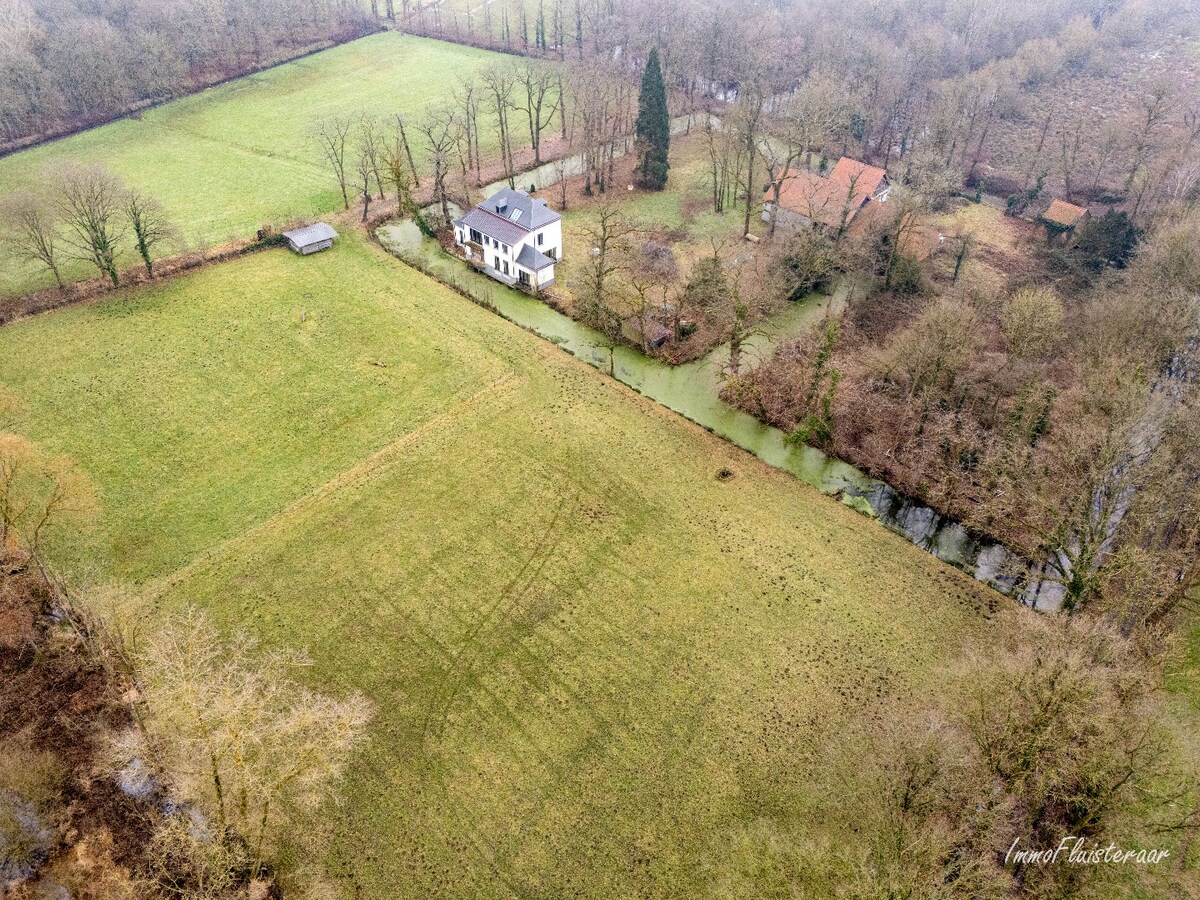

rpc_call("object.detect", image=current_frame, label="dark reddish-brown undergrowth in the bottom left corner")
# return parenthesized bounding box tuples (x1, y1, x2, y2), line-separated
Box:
(0, 554, 155, 900)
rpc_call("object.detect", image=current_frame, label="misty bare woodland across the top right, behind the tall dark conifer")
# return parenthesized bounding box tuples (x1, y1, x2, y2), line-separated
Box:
(410, 0, 1200, 224)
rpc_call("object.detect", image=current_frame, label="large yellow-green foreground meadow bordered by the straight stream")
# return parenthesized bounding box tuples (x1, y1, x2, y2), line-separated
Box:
(0, 238, 988, 898)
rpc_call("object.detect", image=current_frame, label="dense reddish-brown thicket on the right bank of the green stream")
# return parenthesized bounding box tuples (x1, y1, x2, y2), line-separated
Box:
(727, 198, 1200, 619)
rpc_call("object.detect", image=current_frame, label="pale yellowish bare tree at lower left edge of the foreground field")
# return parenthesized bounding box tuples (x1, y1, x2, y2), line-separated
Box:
(139, 612, 371, 870)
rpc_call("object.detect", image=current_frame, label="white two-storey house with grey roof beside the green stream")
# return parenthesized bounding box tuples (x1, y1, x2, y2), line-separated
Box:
(454, 187, 563, 292)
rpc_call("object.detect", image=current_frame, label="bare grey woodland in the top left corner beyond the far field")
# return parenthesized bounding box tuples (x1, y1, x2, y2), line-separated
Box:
(0, 0, 372, 146)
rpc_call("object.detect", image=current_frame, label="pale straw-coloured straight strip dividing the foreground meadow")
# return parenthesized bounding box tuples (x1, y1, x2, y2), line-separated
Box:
(139, 372, 527, 601)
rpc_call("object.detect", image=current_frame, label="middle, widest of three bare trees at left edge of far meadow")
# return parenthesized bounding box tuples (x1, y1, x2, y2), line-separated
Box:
(59, 167, 125, 287)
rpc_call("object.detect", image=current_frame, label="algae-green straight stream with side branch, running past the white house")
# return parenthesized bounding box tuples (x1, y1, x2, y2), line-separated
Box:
(377, 222, 1061, 611)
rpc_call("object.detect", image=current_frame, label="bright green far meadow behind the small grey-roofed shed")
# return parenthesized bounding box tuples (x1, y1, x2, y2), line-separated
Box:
(0, 32, 497, 296)
